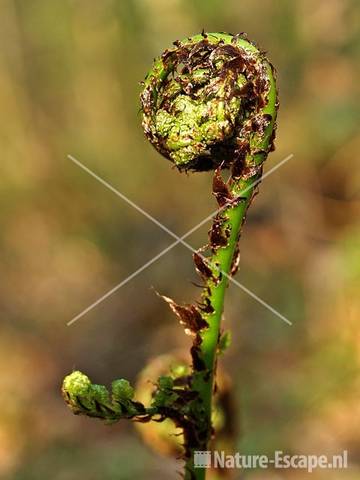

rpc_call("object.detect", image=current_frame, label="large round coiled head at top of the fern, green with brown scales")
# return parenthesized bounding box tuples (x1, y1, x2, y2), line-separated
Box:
(141, 33, 274, 171)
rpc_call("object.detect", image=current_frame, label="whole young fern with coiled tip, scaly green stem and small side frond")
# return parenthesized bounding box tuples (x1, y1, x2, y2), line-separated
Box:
(62, 32, 278, 480)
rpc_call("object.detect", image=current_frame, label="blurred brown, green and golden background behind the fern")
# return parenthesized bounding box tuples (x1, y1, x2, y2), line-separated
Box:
(0, 0, 360, 480)
